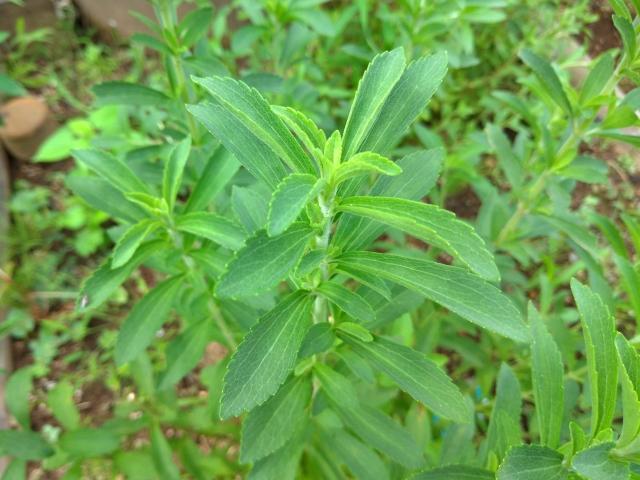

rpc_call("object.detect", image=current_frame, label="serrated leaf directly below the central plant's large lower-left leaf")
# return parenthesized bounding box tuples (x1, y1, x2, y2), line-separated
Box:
(240, 377, 311, 463)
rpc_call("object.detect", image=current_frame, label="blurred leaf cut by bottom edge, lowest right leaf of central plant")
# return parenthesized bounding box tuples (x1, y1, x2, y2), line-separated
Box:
(321, 430, 389, 480)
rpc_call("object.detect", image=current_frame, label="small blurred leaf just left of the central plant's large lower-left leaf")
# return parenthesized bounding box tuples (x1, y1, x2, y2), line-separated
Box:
(158, 319, 211, 390)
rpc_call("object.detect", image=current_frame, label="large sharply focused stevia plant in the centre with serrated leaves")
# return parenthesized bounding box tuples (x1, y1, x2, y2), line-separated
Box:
(189, 49, 528, 478)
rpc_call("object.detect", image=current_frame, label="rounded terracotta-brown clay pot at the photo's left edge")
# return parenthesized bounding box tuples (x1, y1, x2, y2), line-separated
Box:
(0, 96, 58, 161)
